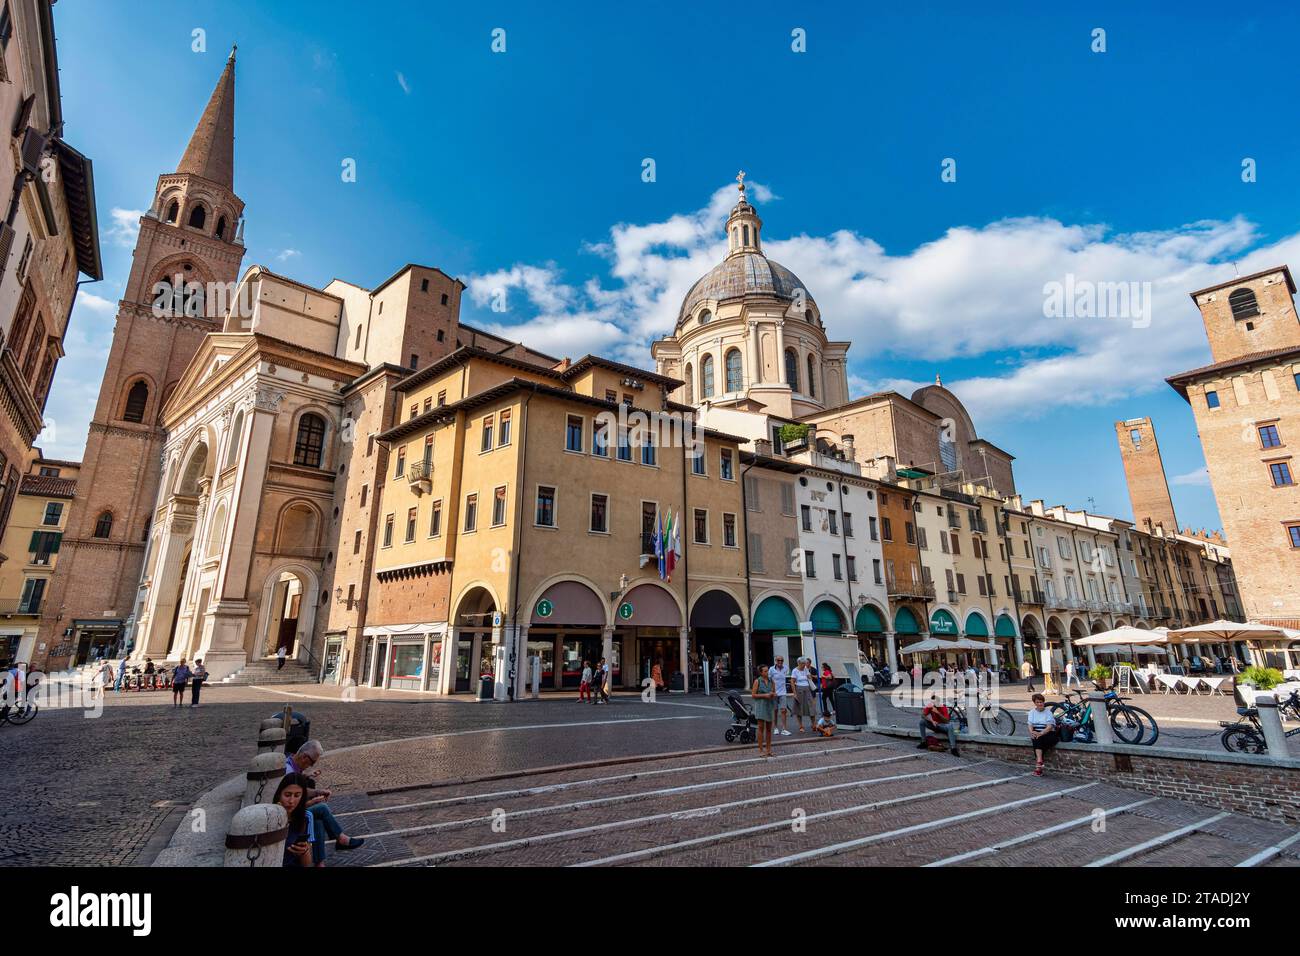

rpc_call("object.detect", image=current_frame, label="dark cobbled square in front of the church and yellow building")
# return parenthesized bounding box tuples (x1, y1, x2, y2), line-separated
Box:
(0, 685, 725, 866)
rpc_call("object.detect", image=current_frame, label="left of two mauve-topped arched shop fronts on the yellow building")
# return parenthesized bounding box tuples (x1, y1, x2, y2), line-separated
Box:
(524, 581, 608, 691)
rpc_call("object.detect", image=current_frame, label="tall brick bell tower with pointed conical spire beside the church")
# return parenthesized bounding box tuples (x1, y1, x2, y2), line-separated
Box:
(33, 49, 244, 670)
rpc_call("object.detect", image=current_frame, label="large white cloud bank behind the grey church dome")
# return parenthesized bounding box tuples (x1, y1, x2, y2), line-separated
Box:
(469, 183, 1279, 424)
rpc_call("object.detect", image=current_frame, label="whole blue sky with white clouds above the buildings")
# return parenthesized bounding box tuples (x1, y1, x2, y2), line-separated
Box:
(43, 0, 1300, 538)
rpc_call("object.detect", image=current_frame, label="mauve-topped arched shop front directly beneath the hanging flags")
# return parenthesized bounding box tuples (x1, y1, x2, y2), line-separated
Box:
(612, 584, 686, 691)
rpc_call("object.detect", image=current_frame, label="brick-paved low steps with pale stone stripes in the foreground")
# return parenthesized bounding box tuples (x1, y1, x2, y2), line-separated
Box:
(312, 734, 1300, 866)
